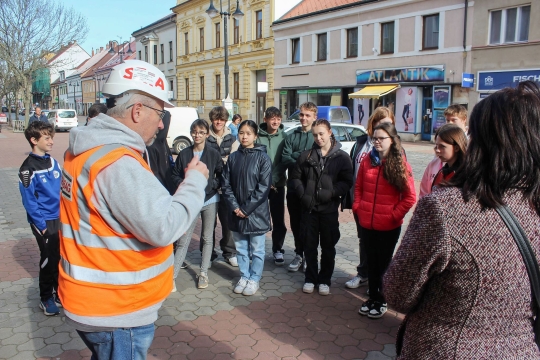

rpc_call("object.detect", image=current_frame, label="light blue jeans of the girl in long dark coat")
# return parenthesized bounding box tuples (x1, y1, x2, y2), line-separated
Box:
(232, 231, 265, 283)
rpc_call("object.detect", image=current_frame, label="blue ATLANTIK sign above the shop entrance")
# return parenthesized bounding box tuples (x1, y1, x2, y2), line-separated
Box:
(356, 65, 444, 85)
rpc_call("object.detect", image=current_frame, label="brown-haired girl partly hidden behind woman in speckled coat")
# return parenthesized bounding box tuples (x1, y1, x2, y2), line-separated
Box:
(431, 124, 467, 191)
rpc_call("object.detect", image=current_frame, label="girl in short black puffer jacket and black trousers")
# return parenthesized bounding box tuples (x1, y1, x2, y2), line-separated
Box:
(289, 119, 353, 295)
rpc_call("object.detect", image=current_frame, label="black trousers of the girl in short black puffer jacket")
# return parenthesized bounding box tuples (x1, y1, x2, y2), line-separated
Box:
(302, 211, 340, 286)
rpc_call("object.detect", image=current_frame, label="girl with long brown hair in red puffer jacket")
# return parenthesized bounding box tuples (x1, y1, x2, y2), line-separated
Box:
(353, 123, 416, 319)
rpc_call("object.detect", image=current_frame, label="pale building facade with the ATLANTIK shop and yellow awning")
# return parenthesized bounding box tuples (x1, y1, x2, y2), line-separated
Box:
(272, 0, 475, 140)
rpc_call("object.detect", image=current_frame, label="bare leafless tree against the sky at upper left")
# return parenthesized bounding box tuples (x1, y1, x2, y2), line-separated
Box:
(0, 0, 88, 122)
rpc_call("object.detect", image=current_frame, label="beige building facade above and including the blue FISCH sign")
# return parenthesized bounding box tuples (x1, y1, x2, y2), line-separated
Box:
(469, 0, 540, 104)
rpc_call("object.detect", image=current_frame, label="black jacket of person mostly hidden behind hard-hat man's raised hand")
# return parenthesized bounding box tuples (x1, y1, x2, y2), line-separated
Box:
(145, 111, 178, 195)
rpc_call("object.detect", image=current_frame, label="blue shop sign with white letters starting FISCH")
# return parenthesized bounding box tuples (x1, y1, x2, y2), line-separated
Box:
(477, 69, 540, 91)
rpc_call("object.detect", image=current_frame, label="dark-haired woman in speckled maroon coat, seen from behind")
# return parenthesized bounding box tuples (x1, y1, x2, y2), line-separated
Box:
(384, 81, 540, 360)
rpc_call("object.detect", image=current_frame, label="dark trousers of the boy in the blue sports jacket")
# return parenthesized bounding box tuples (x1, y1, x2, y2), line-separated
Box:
(30, 219, 60, 301)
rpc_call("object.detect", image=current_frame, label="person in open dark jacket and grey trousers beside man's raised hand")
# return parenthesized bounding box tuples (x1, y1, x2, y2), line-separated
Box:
(172, 119, 223, 292)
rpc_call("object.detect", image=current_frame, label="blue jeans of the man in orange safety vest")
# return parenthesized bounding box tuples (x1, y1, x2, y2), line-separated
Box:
(77, 324, 154, 360)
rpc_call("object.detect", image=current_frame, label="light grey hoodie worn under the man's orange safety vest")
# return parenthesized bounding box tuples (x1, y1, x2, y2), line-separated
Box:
(61, 114, 207, 328)
